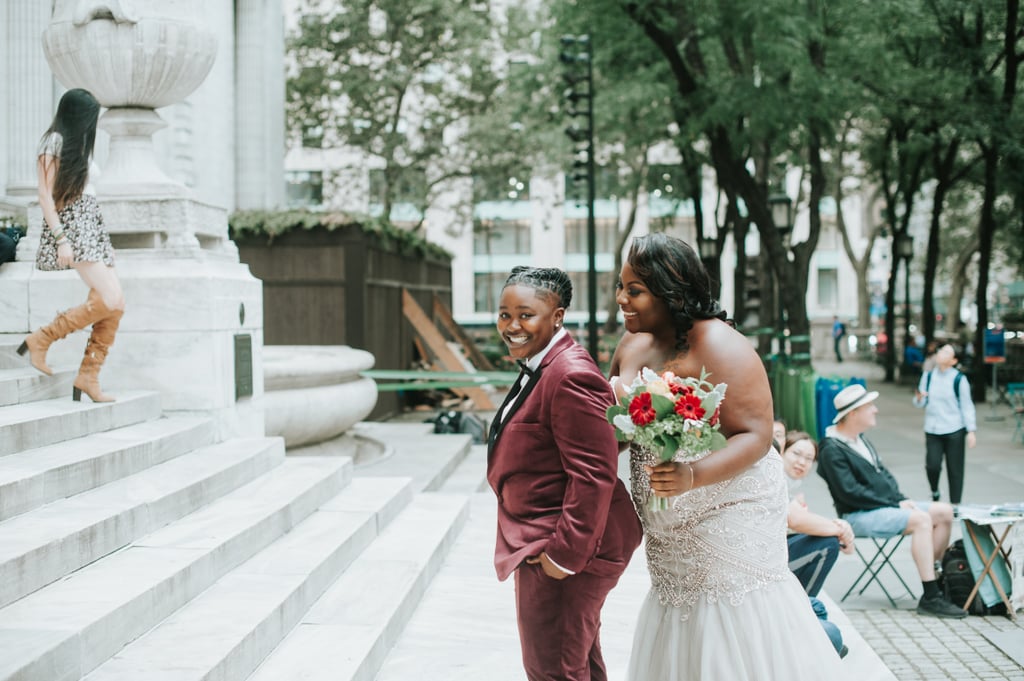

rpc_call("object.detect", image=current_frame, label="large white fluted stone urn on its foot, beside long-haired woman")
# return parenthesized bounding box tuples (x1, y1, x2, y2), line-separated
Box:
(43, 0, 217, 198)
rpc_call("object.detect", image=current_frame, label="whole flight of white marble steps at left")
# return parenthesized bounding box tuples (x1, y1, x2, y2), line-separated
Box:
(0, 345, 478, 681)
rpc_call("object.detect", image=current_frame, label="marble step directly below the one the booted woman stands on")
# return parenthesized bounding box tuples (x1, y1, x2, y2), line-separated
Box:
(0, 417, 215, 520)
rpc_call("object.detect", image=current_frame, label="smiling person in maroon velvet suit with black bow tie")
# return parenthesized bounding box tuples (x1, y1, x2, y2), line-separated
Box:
(487, 267, 642, 681)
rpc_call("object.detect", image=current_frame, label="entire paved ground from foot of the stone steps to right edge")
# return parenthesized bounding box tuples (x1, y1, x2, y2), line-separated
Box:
(385, 361, 1024, 681)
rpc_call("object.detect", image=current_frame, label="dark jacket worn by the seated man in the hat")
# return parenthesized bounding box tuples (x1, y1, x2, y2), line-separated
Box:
(818, 436, 906, 516)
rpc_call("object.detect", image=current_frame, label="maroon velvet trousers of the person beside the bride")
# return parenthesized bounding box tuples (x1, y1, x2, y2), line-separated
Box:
(515, 563, 618, 681)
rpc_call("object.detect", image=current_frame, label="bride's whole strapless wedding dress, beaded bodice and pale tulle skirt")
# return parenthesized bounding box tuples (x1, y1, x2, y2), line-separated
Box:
(629, 445, 847, 681)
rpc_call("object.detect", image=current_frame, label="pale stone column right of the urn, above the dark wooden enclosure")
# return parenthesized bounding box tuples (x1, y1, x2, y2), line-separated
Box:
(234, 0, 285, 209)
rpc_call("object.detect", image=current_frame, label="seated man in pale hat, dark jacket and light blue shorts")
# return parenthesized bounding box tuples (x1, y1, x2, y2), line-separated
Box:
(818, 384, 967, 619)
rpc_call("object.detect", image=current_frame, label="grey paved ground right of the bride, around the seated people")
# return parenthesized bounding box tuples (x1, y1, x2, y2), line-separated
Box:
(804, 360, 1024, 681)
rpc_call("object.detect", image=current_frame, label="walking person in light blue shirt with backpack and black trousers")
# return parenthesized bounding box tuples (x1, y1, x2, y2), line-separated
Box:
(913, 343, 978, 504)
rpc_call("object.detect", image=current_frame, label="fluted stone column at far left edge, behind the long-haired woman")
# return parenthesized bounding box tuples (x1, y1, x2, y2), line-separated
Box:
(3, 0, 54, 197)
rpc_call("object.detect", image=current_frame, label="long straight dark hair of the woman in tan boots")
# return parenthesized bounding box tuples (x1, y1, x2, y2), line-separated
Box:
(43, 88, 99, 209)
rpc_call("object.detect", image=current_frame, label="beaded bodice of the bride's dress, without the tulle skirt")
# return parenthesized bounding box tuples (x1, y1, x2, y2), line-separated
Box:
(630, 444, 788, 620)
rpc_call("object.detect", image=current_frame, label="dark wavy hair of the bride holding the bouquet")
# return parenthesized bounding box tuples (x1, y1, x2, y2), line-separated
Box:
(626, 232, 728, 350)
